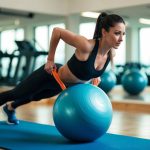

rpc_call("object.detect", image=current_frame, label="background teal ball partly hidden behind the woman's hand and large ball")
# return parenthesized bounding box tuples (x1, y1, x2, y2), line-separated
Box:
(98, 71, 117, 93)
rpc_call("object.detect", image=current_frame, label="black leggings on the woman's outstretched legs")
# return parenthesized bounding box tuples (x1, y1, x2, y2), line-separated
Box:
(0, 64, 62, 108)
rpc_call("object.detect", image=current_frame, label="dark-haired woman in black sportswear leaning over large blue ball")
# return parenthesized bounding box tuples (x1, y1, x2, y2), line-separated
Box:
(0, 13, 125, 124)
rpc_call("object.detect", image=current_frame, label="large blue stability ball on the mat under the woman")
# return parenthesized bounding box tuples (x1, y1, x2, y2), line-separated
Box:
(53, 84, 112, 142)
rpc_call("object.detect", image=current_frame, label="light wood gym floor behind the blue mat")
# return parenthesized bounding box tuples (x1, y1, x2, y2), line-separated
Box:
(0, 87, 150, 139)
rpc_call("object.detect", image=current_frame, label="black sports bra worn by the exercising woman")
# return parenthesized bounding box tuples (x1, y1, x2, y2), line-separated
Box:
(67, 40, 110, 81)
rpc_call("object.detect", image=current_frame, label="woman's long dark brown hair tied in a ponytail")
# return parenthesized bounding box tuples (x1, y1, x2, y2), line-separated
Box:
(93, 12, 125, 68)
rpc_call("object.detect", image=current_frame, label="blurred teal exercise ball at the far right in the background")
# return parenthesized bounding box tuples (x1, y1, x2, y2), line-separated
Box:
(121, 69, 148, 95)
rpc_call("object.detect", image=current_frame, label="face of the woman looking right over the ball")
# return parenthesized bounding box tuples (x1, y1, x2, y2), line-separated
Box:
(103, 23, 125, 49)
